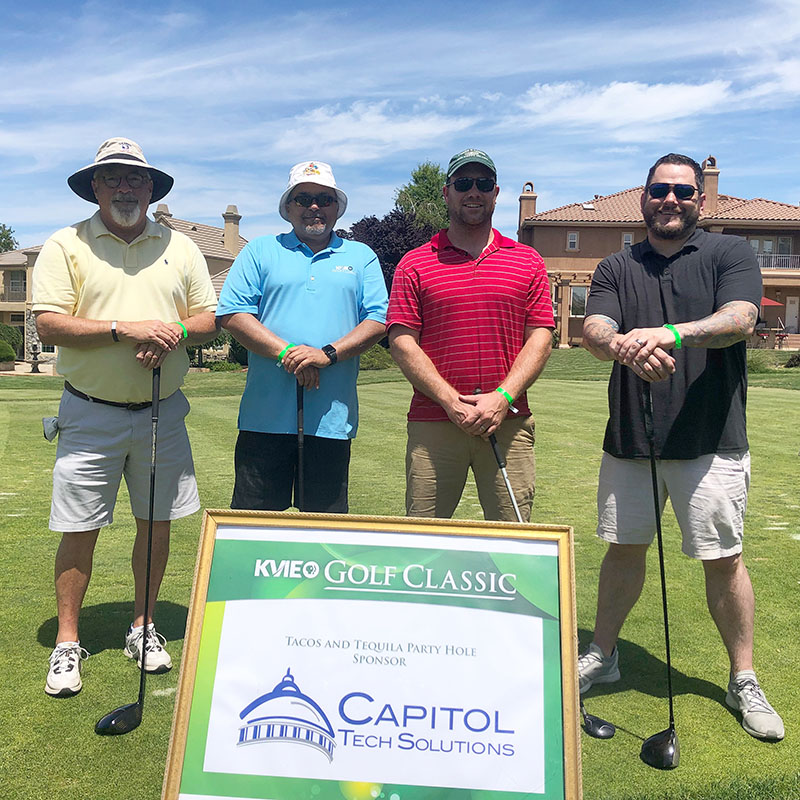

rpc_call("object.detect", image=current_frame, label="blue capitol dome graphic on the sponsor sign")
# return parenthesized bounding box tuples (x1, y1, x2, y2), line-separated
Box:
(237, 668, 336, 761)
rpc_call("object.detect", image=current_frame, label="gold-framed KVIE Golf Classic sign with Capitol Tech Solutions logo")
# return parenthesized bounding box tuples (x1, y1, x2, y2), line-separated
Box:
(163, 511, 580, 800)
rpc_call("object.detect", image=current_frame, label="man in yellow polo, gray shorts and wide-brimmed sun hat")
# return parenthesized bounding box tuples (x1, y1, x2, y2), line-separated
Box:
(33, 138, 217, 696)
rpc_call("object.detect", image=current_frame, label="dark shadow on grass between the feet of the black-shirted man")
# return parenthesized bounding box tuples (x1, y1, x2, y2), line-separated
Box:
(578, 628, 736, 716)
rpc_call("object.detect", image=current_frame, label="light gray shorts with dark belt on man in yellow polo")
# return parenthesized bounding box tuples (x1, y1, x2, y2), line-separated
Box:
(50, 391, 200, 533)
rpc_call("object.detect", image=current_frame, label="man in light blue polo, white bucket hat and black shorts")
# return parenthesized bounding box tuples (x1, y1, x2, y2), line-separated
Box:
(217, 161, 387, 513)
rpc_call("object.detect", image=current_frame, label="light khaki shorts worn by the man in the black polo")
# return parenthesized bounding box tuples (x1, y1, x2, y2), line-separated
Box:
(597, 452, 750, 561)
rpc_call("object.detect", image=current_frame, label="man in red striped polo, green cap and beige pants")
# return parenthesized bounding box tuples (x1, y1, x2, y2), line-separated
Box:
(387, 150, 555, 520)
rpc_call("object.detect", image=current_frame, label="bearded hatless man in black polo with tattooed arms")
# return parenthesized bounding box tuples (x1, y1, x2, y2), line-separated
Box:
(578, 153, 784, 739)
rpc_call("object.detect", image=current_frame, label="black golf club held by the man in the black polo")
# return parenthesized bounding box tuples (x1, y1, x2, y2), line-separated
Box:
(640, 381, 681, 769)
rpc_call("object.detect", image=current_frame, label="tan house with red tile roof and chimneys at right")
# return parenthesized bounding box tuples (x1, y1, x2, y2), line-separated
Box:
(517, 156, 800, 346)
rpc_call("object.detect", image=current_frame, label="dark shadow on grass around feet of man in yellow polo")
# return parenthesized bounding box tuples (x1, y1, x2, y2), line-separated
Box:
(36, 600, 189, 655)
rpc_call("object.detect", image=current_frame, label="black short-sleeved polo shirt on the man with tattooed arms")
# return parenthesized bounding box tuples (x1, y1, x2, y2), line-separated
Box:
(586, 229, 761, 459)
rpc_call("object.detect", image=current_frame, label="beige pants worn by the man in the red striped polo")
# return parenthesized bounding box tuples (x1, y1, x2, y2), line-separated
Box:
(406, 417, 536, 522)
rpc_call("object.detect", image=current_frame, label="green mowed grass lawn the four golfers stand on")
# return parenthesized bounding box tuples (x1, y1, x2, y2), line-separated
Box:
(0, 350, 800, 800)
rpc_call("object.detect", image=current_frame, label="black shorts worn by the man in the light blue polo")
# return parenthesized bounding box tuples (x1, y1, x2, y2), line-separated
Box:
(231, 431, 350, 514)
